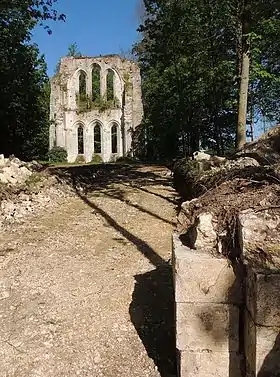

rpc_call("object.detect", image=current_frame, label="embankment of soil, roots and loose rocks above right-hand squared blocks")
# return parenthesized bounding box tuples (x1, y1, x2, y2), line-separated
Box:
(174, 127, 280, 269)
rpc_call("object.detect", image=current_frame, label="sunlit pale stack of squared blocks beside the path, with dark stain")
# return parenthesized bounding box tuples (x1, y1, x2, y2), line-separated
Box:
(173, 235, 241, 377)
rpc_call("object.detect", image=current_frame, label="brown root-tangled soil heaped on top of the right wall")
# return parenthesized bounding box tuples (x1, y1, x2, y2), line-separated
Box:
(174, 157, 280, 262)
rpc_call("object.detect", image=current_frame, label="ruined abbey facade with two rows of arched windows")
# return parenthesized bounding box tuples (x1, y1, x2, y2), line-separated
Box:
(50, 55, 143, 162)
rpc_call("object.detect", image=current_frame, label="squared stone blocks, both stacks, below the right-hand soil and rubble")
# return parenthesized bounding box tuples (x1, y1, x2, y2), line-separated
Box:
(173, 234, 280, 377)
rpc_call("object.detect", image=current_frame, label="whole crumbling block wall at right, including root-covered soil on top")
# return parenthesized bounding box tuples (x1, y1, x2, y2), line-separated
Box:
(173, 127, 280, 377)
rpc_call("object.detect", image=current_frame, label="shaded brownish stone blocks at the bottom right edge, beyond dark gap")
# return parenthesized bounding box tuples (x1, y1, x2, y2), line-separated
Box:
(244, 268, 280, 377)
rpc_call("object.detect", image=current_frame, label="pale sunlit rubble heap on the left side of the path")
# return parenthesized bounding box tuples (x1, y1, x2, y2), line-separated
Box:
(0, 155, 70, 228)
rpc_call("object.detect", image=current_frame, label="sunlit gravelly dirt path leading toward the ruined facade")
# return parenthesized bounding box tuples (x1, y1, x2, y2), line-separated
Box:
(0, 167, 175, 377)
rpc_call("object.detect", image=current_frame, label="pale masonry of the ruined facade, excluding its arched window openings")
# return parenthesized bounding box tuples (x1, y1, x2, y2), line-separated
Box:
(50, 56, 143, 162)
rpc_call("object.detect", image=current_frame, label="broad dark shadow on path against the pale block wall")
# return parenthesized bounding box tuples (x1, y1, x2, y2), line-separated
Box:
(129, 264, 176, 377)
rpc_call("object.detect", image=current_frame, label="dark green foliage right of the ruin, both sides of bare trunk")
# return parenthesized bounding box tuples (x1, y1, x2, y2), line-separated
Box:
(134, 0, 280, 160)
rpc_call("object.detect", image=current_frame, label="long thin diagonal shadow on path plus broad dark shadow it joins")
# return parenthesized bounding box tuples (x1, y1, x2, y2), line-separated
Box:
(63, 168, 176, 377)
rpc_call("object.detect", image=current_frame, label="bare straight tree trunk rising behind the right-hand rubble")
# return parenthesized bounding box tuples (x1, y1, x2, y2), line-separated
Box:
(236, 49, 250, 149)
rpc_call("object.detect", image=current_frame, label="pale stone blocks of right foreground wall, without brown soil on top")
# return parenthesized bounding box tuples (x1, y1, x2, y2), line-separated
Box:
(173, 207, 280, 377)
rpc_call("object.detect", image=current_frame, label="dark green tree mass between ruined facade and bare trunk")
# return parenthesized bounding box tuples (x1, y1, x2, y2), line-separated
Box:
(136, 0, 236, 158)
